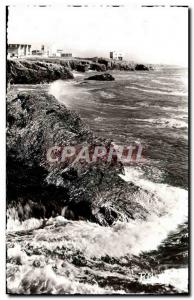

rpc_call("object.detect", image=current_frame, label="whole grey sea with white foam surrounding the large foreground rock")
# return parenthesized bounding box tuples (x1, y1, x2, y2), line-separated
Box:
(7, 68, 188, 294)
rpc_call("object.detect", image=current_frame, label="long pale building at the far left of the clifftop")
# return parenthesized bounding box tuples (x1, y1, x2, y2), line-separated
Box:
(7, 44, 31, 58)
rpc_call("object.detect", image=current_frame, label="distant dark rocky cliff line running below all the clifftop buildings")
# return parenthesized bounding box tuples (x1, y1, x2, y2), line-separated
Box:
(7, 57, 152, 84)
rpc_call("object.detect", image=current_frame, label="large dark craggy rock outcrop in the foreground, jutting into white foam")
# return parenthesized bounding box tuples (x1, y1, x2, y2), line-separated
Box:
(7, 91, 147, 225)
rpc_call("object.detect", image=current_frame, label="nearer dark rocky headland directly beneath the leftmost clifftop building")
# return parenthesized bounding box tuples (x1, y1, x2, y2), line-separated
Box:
(7, 60, 73, 84)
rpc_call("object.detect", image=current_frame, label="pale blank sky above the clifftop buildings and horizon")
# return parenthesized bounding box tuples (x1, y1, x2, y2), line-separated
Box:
(8, 5, 188, 66)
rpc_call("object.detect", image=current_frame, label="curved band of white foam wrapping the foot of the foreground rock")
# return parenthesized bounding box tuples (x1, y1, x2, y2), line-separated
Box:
(7, 168, 187, 257)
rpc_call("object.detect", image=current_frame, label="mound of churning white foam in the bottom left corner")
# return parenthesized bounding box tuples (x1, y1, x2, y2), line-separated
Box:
(7, 265, 111, 294)
